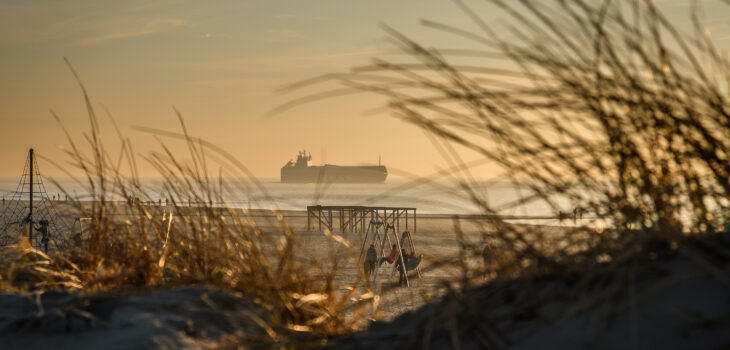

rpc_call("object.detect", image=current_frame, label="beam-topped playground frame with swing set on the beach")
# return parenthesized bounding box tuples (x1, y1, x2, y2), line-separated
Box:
(307, 205, 421, 286)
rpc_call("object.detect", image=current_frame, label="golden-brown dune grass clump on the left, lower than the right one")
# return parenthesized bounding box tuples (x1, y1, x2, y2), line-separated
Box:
(0, 61, 373, 344)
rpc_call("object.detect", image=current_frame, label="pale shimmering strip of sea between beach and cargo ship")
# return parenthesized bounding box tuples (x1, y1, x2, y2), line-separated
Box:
(0, 178, 574, 224)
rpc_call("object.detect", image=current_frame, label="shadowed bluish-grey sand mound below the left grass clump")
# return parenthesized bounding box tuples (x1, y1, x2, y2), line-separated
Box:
(0, 287, 265, 350)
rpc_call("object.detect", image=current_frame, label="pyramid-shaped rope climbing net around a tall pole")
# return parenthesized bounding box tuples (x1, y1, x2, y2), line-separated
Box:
(0, 148, 68, 251)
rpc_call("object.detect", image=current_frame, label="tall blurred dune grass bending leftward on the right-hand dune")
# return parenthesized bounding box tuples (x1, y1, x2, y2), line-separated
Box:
(274, 0, 730, 282)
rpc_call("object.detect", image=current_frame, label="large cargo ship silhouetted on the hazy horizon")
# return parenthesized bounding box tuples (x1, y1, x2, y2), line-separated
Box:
(281, 151, 388, 183)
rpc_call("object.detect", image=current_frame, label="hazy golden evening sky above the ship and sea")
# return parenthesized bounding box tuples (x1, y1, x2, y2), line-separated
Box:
(0, 0, 730, 178)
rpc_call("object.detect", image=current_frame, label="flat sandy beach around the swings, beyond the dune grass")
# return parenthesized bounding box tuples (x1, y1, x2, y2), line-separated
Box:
(0, 197, 564, 320)
